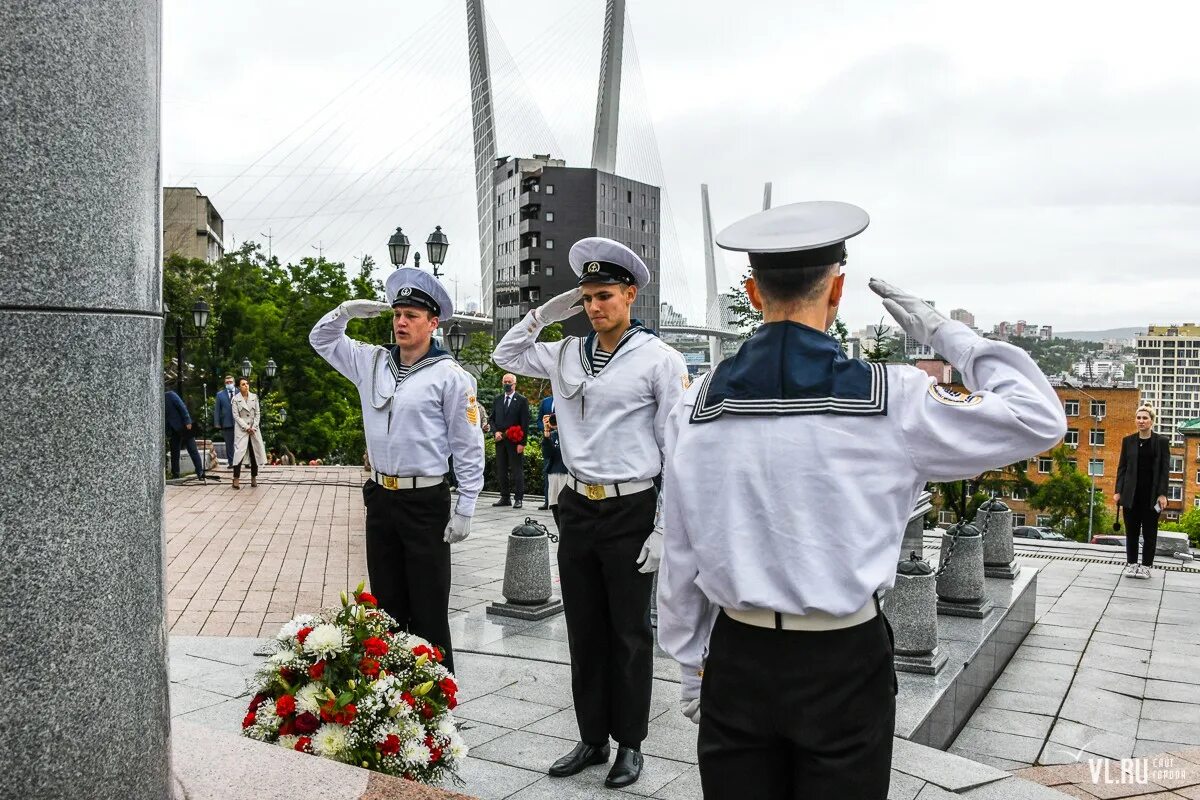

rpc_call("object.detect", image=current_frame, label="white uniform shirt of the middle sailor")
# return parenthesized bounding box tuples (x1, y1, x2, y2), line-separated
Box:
(492, 312, 689, 483)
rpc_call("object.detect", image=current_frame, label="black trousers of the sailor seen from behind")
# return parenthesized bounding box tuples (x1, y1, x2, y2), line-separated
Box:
(697, 613, 895, 800)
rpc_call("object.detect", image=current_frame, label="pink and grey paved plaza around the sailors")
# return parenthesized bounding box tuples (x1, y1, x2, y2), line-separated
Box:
(167, 467, 1200, 800)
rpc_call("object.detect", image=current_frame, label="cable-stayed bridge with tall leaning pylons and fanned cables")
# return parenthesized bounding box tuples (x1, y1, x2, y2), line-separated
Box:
(187, 0, 736, 359)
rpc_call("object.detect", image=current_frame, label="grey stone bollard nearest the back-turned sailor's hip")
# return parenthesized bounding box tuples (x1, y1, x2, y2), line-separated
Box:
(884, 552, 946, 675)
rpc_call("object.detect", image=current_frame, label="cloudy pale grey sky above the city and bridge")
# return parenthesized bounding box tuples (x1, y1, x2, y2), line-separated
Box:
(163, 0, 1200, 330)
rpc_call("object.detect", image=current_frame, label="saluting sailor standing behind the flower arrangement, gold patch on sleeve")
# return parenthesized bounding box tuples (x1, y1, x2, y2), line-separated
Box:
(308, 267, 484, 670)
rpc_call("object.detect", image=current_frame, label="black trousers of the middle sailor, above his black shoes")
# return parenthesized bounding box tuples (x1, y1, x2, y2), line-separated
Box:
(558, 488, 656, 747)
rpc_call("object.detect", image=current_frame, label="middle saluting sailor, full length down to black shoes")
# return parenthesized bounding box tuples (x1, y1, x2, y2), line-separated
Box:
(492, 236, 688, 788)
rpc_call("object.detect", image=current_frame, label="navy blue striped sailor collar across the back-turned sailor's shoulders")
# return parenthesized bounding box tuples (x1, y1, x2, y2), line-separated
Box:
(689, 321, 888, 423)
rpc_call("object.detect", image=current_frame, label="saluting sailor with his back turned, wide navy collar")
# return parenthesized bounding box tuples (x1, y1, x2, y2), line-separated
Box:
(658, 203, 1067, 800)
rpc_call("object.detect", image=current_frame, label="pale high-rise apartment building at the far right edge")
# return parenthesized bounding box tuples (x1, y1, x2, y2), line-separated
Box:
(1136, 323, 1200, 445)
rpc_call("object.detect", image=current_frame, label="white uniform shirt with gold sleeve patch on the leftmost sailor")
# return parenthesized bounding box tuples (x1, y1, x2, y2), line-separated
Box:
(308, 303, 484, 517)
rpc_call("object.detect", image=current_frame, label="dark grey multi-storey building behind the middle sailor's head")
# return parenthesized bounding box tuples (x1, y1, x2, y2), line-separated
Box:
(492, 155, 661, 338)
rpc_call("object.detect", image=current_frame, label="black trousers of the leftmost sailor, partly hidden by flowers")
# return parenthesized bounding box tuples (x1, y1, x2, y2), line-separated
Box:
(362, 480, 454, 672)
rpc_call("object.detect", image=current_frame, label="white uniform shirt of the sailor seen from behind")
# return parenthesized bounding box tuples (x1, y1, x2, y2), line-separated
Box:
(658, 321, 1067, 697)
